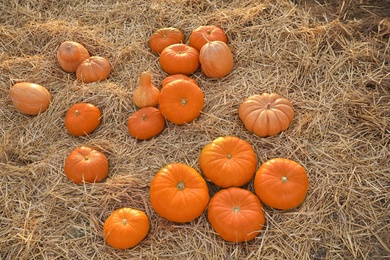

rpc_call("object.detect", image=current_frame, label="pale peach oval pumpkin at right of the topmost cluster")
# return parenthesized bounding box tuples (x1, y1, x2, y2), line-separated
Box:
(199, 41, 233, 78)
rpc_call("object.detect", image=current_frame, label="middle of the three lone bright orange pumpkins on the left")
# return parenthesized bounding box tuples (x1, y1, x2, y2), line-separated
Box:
(64, 146, 108, 184)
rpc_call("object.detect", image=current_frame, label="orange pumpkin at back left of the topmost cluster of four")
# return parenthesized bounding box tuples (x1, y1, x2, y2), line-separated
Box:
(149, 27, 184, 53)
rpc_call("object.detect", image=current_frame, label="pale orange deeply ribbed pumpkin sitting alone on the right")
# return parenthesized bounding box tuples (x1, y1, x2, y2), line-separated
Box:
(238, 93, 294, 137)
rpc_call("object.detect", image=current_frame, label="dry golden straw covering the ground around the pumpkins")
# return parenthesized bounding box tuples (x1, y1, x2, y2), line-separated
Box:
(0, 0, 390, 259)
